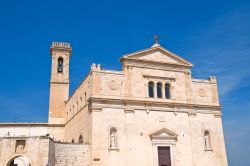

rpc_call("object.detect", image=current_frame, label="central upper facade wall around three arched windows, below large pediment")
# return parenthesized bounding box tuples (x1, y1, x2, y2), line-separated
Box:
(129, 67, 187, 102)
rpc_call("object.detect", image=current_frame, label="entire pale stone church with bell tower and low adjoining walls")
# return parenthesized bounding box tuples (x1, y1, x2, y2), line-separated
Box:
(0, 41, 228, 166)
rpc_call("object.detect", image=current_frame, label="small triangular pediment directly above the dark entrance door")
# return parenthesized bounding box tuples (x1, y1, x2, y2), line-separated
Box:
(150, 128, 178, 140)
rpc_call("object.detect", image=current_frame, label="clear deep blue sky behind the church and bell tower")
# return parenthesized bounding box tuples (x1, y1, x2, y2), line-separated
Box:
(0, 0, 250, 166)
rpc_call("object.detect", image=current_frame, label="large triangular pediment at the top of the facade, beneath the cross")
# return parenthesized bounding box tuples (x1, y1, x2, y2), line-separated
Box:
(121, 45, 193, 67)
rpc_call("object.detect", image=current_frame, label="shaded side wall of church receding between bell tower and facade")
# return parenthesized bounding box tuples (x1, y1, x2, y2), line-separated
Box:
(65, 75, 92, 143)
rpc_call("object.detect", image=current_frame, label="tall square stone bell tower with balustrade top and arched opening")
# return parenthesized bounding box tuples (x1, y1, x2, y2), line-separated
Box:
(49, 42, 72, 124)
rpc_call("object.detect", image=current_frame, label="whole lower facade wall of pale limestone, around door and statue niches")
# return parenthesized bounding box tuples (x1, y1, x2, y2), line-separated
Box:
(92, 107, 227, 166)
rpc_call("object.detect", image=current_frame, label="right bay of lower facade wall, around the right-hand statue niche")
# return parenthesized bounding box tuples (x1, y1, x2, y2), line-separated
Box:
(189, 113, 227, 166)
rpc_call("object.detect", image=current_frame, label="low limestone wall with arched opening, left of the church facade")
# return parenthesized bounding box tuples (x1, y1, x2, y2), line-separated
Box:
(0, 137, 90, 166)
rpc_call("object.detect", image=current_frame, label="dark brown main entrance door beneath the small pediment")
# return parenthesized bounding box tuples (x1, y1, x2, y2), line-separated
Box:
(158, 146, 171, 166)
